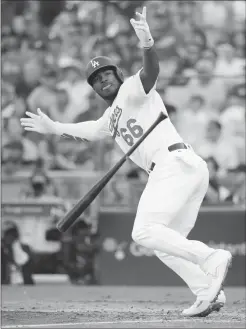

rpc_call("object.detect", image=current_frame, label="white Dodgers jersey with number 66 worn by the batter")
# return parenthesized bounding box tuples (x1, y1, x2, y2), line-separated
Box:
(100, 71, 183, 170)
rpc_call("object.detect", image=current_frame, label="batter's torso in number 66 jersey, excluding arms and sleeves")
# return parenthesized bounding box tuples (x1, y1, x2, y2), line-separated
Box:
(107, 80, 183, 169)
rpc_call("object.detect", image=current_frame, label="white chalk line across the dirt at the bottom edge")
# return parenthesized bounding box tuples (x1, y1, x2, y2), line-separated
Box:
(1, 318, 244, 329)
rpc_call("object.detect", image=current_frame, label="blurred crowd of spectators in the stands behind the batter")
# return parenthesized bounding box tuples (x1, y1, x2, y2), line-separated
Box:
(1, 0, 246, 204)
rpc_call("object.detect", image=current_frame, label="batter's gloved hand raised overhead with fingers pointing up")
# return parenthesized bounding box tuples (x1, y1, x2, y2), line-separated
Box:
(130, 7, 154, 48)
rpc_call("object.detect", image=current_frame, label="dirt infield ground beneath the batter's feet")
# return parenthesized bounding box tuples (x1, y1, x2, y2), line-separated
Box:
(2, 284, 246, 329)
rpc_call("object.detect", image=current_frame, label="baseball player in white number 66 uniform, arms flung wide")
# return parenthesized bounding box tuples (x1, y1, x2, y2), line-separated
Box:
(21, 7, 232, 316)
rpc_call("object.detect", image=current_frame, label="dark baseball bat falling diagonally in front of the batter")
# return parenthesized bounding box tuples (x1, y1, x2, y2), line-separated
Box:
(57, 112, 167, 232)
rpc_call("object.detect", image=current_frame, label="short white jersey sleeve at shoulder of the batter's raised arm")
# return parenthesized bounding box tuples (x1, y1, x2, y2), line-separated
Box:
(126, 69, 157, 103)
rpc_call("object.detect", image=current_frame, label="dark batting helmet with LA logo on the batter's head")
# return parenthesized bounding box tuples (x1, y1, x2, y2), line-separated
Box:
(86, 56, 124, 86)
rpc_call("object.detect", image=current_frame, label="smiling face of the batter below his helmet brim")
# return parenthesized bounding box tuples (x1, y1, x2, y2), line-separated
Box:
(92, 69, 121, 102)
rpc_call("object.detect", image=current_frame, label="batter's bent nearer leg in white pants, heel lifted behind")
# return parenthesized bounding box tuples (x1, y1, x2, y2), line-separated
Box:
(132, 152, 231, 301)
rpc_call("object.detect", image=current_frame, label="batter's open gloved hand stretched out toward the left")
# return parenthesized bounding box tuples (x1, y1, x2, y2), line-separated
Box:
(20, 109, 56, 134)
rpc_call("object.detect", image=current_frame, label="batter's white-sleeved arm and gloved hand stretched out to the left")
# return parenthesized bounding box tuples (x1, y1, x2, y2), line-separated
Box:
(21, 109, 108, 141)
